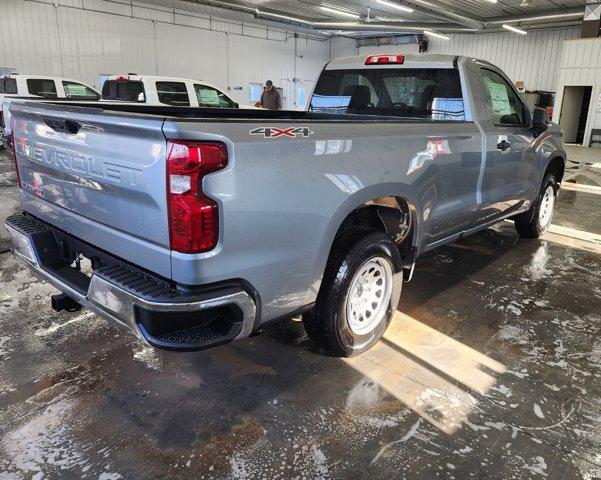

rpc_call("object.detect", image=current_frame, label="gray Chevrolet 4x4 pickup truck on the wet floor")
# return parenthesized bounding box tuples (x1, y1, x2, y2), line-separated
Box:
(6, 55, 565, 356)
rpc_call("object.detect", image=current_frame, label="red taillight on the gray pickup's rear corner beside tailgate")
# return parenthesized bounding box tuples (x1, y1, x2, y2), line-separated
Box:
(167, 141, 227, 253)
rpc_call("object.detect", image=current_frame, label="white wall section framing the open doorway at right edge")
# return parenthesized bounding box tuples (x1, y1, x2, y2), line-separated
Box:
(553, 38, 601, 146)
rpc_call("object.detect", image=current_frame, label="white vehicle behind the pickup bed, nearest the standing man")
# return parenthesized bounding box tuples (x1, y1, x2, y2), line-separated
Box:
(102, 74, 253, 108)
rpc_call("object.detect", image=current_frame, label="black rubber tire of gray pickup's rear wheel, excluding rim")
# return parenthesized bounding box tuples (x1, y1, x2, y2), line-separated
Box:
(303, 230, 403, 357)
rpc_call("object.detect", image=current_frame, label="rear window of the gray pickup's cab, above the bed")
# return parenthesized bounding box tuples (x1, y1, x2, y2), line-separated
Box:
(309, 68, 465, 120)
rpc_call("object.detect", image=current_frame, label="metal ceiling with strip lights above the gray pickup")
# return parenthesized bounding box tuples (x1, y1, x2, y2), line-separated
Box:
(186, 0, 586, 36)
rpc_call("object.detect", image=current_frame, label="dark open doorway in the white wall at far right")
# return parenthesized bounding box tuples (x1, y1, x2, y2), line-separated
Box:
(559, 86, 593, 145)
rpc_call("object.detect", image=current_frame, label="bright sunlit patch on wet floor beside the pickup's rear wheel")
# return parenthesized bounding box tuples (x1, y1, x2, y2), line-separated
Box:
(345, 312, 506, 435)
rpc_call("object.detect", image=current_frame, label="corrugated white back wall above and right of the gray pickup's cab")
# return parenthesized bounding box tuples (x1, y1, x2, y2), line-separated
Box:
(428, 27, 580, 91)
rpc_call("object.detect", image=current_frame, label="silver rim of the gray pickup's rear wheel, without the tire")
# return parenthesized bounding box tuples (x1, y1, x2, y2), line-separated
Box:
(346, 257, 392, 335)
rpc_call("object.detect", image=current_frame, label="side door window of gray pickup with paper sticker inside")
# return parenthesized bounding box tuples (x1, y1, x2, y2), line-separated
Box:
(481, 69, 526, 126)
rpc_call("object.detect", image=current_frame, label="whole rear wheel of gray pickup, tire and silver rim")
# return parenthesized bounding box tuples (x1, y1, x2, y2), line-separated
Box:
(303, 232, 402, 357)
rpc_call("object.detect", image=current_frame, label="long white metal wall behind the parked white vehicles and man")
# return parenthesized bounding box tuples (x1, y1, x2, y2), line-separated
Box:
(0, 0, 329, 108)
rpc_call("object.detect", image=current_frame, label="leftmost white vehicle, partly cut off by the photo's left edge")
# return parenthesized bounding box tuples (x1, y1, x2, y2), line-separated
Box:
(0, 73, 100, 148)
